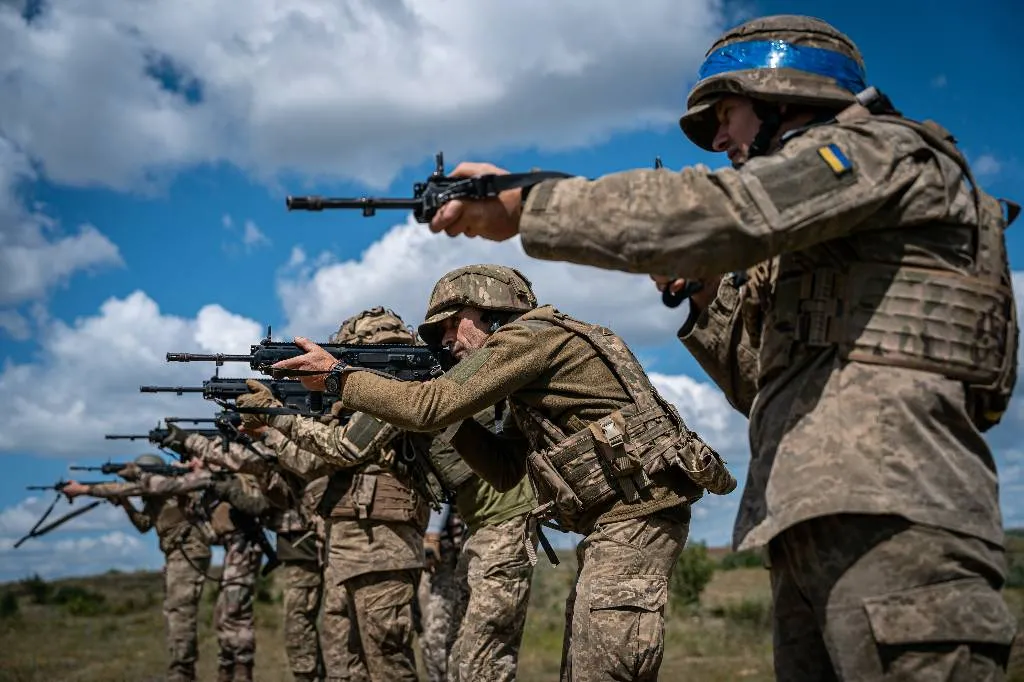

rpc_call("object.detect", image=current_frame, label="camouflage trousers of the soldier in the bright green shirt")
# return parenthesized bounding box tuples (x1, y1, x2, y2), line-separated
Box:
(447, 514, 536, 682)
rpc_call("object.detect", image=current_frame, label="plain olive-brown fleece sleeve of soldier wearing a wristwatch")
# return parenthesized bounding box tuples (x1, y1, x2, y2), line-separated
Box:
(342, 323, 564, 431)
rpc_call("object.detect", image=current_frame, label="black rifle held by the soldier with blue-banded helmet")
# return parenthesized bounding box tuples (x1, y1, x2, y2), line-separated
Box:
(285, 152, 573, 223)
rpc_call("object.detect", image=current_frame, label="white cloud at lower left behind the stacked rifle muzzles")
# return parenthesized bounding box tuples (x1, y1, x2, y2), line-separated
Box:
(0, 292, 262, 457)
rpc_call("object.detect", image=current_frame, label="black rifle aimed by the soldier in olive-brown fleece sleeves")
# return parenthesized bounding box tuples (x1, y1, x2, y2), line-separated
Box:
(167, 327, 454, 376)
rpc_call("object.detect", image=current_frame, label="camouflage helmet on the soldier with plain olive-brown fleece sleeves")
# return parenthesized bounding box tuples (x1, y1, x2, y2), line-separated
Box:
(419, 264, 537, 346)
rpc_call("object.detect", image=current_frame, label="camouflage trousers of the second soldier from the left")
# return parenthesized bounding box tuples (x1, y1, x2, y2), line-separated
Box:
(213, 532, 263, 668)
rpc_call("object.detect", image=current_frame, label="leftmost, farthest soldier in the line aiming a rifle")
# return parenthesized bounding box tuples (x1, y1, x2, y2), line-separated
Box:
(63, 455, 213, 682)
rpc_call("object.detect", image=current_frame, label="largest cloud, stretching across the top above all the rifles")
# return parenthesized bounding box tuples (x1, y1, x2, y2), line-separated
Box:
(0, 0, 725, 188)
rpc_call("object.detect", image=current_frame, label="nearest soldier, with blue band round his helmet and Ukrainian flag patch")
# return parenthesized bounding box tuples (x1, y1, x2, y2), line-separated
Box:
(419, 15, 1019, 680)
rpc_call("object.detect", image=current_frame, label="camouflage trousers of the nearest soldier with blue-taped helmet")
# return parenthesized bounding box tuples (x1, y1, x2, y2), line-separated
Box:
(768, 514, 1016, 682)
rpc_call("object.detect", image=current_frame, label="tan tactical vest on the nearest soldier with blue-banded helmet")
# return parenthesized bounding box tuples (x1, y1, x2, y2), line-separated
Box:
(759, 111, 1019, 431)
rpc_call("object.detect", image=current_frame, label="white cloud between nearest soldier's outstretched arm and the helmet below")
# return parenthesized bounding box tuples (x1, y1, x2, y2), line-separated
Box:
(278, 218, 686, 344)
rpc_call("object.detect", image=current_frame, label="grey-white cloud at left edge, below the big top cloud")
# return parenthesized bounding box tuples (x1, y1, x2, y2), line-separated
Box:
(0, 139, 123, 339)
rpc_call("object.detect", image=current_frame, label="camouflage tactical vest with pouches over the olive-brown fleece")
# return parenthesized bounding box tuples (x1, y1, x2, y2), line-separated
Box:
(509, 306, 736, 530)
